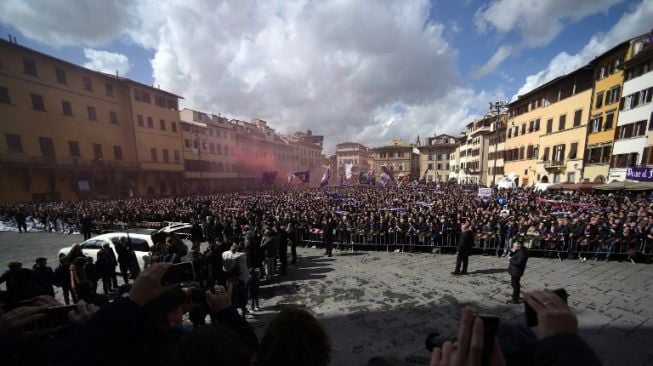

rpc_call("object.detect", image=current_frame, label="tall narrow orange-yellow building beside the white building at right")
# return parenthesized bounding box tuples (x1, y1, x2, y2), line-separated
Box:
(583, 41, 631, 182)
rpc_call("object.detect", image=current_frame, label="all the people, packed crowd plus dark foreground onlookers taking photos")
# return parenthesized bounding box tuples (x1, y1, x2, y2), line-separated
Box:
(0, 185, 653, 365)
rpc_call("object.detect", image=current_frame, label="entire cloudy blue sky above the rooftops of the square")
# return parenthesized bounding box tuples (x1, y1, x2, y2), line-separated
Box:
(0, 0, 653, 153)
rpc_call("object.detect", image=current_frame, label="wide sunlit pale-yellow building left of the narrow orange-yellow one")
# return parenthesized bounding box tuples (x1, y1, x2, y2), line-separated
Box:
(506, 67, 593, 186)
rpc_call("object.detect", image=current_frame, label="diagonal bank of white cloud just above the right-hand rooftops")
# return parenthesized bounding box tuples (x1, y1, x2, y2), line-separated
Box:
(513, 0, 653, 99)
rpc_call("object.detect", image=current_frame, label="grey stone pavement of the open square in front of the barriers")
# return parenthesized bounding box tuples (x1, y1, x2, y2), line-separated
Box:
(0, 232, 653, 365)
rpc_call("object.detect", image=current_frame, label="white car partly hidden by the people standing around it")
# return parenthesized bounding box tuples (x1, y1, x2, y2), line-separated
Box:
(59, 232, 154, 268)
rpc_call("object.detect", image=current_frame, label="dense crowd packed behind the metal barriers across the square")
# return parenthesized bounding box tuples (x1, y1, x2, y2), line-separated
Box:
(0, 185, 653, 260)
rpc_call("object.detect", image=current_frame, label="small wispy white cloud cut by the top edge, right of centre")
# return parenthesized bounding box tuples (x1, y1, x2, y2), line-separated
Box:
(474, 0, 624, 47)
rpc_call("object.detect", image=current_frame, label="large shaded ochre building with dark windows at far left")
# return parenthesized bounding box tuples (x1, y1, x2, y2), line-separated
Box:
(0, 41, 183, 201)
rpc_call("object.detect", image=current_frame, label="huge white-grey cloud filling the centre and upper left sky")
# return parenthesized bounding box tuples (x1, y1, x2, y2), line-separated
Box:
(0, 0, 494, 152)
